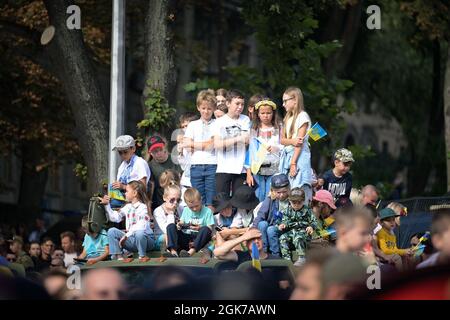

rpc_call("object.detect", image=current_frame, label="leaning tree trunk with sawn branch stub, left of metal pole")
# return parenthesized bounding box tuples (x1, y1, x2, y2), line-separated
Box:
(44, 0, 108, 193)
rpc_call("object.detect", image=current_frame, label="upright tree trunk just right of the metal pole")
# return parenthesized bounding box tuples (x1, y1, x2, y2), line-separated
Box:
(143, 0, 176, 110)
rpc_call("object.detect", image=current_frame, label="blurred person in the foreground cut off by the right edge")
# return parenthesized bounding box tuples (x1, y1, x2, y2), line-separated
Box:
(417, 204, 450, 269)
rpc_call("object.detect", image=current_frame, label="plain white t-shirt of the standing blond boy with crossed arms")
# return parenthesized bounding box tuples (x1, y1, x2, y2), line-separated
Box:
(184, 119, 217, 165)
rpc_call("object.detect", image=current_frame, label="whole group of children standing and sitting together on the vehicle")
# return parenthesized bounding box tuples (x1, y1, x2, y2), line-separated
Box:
(70, 87, 446, 269)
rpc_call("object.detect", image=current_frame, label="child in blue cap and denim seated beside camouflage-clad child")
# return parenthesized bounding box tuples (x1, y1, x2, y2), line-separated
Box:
(253, 174, 290, 256)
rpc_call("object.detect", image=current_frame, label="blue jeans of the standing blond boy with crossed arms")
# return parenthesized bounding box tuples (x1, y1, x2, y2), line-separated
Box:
(191, 164, 217, 206)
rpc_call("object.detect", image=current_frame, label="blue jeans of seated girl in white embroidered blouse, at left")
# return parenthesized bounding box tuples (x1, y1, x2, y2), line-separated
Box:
(108, 228, 155, 257)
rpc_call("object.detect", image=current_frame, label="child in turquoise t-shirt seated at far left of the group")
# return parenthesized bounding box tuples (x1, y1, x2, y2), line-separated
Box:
(78, 216, 109, 264)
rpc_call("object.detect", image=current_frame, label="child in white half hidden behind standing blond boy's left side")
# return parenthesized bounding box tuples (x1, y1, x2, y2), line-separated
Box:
(174, 112, 198, 192)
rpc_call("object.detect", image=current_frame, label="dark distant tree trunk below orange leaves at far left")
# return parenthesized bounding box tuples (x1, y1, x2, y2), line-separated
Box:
(17, 141, 48, 223)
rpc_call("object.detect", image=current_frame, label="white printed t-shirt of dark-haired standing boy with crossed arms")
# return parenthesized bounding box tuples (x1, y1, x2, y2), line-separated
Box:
(213, 114, 250, 174)
